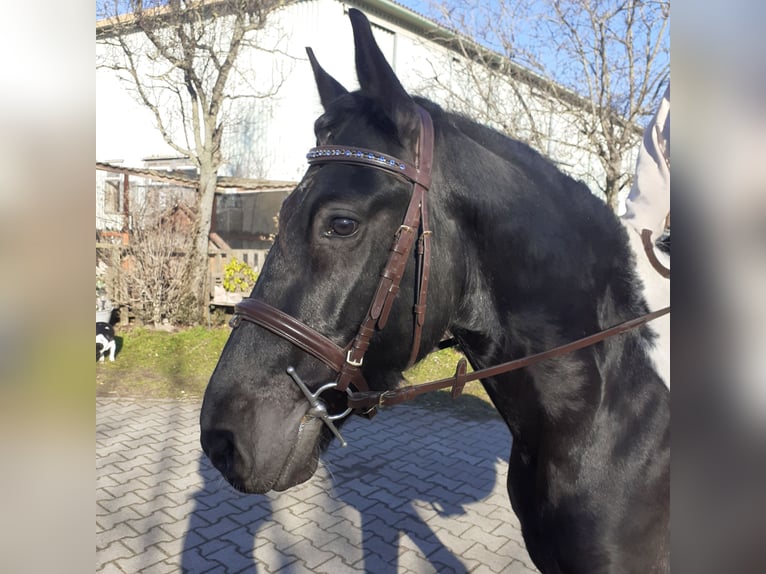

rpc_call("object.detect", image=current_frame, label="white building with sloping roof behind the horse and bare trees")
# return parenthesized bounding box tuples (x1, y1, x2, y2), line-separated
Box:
(96, 0, 633, 235)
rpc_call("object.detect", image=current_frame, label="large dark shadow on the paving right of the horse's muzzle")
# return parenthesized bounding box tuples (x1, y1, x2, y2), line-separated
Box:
(325, 397, 510, 574)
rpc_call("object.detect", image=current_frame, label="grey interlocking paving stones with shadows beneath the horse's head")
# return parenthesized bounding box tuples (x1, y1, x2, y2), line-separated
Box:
(96, 398, 535, 574)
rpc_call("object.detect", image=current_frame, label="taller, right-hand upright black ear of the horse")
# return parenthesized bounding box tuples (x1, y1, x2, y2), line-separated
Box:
(348, 8, 419, 140)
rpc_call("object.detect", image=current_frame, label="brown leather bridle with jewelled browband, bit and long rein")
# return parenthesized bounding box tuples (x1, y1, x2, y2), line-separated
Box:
(230, 106, 670, 428)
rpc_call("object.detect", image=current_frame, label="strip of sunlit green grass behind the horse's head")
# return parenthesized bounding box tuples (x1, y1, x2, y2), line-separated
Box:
(96, 327, 497, 419)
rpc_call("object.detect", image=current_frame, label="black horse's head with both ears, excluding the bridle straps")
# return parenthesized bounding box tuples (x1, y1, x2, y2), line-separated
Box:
(200, 9, 460, 493)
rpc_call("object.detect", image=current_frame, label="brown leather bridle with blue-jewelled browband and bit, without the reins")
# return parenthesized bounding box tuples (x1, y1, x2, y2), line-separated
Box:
(230, 105, 434, 428)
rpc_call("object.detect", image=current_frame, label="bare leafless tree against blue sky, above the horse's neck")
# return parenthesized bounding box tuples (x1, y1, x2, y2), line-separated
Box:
(424, 0, 670, 212)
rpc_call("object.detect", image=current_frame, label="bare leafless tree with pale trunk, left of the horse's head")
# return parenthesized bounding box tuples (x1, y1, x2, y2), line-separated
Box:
(96, 0, 286, 317)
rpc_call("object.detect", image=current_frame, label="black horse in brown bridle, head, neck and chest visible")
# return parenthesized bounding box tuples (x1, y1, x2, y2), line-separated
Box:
(201, 10, 670, 573)
